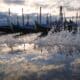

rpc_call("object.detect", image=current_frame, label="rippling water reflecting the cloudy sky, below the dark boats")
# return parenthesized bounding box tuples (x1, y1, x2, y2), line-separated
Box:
(0, 31, 80, 80)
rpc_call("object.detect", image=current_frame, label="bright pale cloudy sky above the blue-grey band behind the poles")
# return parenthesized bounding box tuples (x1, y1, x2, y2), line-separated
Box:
(0, 0, 80, 15)
